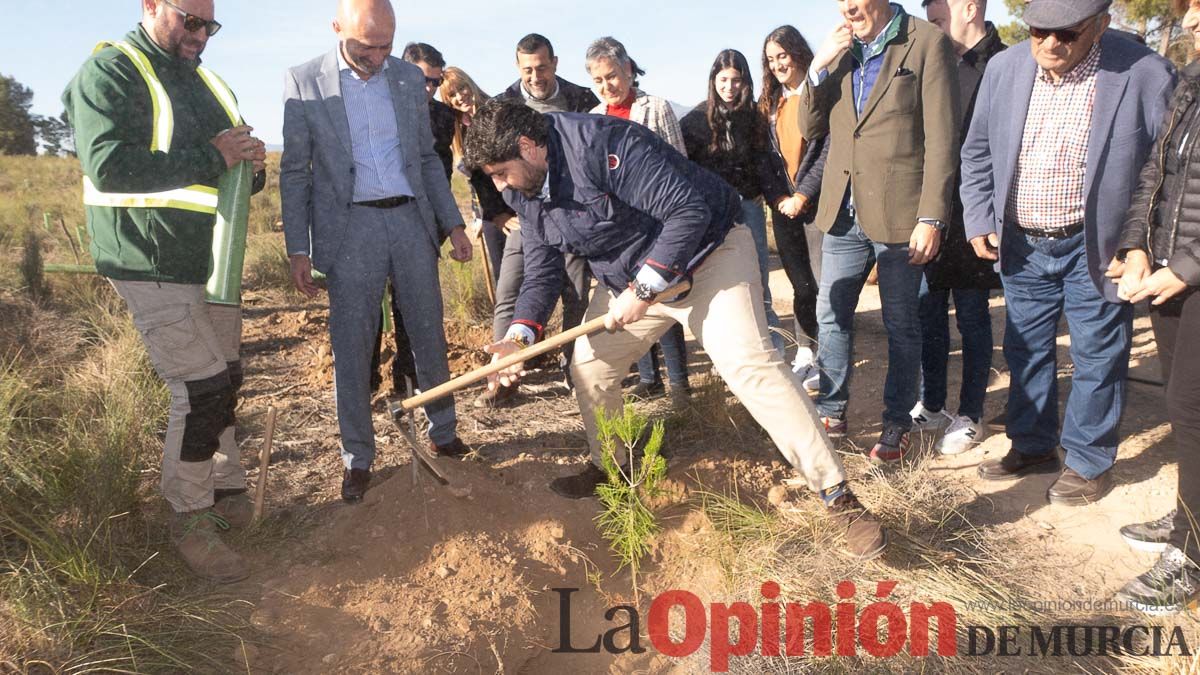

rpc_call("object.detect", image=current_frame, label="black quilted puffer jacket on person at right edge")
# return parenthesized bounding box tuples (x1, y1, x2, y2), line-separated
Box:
(1117, 61, 1200, 286)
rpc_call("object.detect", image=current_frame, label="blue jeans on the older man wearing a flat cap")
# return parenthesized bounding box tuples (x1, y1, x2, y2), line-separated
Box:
(1001, 227, 1133, 479)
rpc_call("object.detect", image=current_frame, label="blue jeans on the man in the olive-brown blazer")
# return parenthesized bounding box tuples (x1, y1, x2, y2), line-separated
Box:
(816, 209, 925, 430)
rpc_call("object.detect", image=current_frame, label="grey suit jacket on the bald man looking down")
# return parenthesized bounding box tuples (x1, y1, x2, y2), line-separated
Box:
(280, 50, 463, 273)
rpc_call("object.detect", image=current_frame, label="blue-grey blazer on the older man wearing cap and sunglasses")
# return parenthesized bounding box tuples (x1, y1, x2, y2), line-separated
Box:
(961, 31, 1175, 303)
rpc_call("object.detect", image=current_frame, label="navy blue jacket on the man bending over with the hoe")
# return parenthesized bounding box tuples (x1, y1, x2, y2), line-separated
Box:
(504, 113, 742, 334)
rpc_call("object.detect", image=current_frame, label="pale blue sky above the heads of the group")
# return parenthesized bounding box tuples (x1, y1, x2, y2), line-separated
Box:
(0, 0, 1007, 144)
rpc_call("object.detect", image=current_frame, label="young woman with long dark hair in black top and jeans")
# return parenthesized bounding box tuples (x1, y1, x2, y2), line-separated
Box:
(679, 49, 792, 356)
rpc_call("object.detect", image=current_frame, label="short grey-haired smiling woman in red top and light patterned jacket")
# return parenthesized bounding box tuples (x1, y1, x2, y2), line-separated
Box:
(584, 37, 691, 407)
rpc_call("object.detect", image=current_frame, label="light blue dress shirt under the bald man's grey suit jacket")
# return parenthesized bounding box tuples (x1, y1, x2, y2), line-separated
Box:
(337, 49, 413, 202)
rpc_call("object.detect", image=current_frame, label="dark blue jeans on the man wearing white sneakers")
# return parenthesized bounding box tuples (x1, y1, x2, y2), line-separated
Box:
(920, 279, 992, 422)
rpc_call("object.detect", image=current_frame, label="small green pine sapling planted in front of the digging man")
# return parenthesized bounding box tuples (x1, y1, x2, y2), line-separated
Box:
(596, 401, 667, 596)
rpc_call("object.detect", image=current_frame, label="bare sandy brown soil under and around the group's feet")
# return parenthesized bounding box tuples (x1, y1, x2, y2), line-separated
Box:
(208, 264, 1190, 674)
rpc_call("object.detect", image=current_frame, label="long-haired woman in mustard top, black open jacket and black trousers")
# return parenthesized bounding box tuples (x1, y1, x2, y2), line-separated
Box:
(758, 25, 829, 389)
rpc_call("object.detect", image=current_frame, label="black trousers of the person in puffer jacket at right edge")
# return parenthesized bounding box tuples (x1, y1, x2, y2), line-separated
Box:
(1150, 293, 1200, 563)
